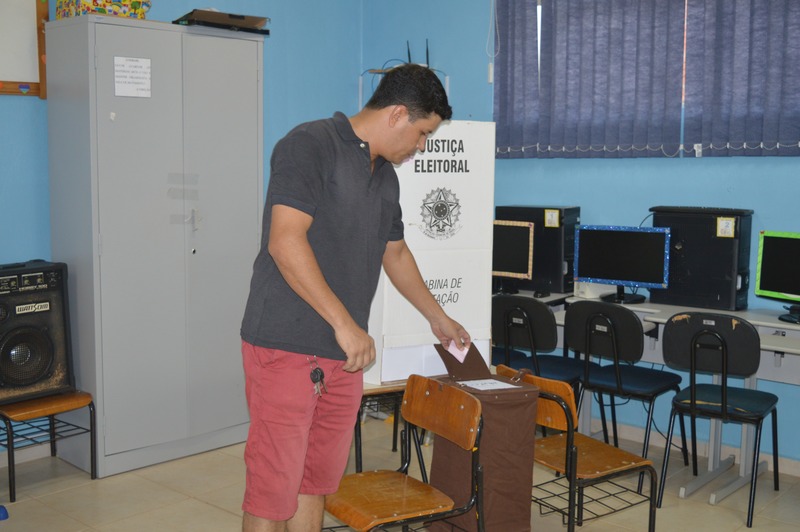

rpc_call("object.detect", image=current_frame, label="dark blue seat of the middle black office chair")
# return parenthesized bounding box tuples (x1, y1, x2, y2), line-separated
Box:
(586, 364, 681, 397)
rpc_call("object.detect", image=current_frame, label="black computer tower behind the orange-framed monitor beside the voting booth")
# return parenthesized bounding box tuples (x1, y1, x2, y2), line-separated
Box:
(495, 205, 581, 293)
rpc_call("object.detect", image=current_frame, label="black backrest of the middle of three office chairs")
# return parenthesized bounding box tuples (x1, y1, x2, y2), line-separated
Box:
(564, 301, 644, 362)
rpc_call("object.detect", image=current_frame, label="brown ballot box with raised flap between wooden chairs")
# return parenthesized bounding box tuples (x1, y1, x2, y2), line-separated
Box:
(429, 346, 539, 532)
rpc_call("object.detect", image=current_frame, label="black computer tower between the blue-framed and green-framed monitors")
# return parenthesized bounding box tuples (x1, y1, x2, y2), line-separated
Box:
(650, 207, 753, 310)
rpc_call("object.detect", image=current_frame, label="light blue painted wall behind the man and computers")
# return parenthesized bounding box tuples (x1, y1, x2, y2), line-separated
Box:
(0, 0, 800, 460)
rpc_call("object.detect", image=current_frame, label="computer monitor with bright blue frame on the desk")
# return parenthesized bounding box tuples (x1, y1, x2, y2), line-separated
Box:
(575, 225, 670, 303)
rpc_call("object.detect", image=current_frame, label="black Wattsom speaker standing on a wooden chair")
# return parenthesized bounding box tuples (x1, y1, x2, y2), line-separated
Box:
(0, 260, 74, 404)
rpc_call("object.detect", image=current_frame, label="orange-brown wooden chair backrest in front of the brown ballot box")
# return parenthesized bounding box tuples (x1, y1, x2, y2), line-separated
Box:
(401, 375, 481, 451)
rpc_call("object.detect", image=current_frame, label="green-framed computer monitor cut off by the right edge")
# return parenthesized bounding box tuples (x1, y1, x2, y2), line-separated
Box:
(755, 231, 800, 323)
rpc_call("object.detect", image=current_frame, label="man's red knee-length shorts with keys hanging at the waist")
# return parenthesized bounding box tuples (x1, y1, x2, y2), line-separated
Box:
(242, 341, 364, 521)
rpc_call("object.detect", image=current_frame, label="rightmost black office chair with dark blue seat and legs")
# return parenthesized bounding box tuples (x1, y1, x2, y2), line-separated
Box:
(658, 312, 779, 527)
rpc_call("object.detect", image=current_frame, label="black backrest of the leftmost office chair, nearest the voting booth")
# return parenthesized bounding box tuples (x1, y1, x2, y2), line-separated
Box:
(492, 294, 558, 353)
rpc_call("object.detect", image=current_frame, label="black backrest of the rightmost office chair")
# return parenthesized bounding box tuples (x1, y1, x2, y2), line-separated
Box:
(662, 312, 761, 377)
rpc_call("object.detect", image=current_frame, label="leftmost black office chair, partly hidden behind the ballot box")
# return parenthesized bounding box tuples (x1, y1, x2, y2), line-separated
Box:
(492, 294, 584, 397)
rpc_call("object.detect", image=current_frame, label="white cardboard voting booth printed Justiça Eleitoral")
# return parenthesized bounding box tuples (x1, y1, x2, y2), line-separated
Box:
(364, 120, 495, 384)
